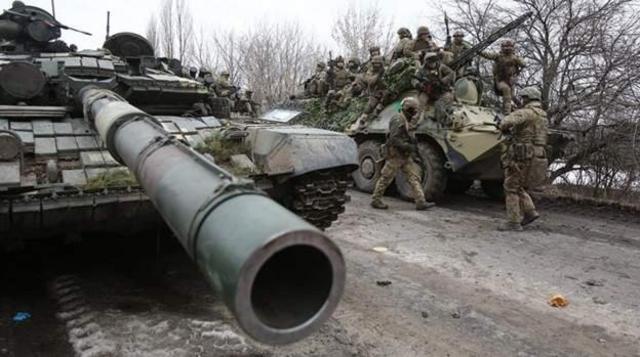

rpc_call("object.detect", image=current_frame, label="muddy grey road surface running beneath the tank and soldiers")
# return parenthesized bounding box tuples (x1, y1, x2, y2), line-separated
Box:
(0, 192, 640, 357)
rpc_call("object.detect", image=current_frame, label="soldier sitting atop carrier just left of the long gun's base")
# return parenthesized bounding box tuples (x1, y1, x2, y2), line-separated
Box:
(414, 52, 456, 110)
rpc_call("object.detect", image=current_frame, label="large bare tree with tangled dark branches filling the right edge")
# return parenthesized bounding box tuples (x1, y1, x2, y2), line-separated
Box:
(450, 0, 640, 197)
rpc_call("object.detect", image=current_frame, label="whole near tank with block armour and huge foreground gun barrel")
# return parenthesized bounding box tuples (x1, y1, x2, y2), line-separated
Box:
(0, 1, 350, 344)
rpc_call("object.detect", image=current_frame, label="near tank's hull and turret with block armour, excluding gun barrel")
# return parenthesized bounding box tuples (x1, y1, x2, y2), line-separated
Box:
(0, 2, 357, 243)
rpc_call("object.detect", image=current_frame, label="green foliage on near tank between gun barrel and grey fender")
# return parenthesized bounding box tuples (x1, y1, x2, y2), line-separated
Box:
(195, 133, 254, 176)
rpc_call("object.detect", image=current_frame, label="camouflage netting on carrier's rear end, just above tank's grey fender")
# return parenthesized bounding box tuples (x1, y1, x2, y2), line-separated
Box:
(300, 98, 367, 132)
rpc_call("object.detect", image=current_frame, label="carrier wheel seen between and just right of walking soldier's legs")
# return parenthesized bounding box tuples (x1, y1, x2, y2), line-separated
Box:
(396, 142, 447, 201)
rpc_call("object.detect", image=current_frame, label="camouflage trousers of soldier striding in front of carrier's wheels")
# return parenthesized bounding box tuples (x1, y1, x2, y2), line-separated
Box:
(372, 154, 426, 203)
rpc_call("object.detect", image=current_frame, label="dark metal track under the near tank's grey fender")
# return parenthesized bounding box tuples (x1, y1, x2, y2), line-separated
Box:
(285, 169, 350, 230)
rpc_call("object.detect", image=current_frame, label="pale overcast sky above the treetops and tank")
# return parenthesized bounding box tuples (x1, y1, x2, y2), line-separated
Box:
(22, 0, 448, 49)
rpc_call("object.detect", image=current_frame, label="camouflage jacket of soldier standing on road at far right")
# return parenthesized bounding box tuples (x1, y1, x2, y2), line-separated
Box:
(500, 101, 548, 148)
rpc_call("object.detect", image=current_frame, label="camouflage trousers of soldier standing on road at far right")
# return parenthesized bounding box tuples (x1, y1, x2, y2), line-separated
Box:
(504, 161, 536, 224)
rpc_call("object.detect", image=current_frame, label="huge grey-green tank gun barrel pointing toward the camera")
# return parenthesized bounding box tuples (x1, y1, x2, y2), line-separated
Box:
(78, 87, 345, 344)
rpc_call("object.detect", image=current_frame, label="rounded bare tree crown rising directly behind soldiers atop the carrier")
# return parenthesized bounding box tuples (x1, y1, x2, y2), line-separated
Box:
(331, 2, 394, 59)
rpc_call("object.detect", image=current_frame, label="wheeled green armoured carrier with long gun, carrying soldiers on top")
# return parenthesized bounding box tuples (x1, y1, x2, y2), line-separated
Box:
(285, 13, 552, 201)
